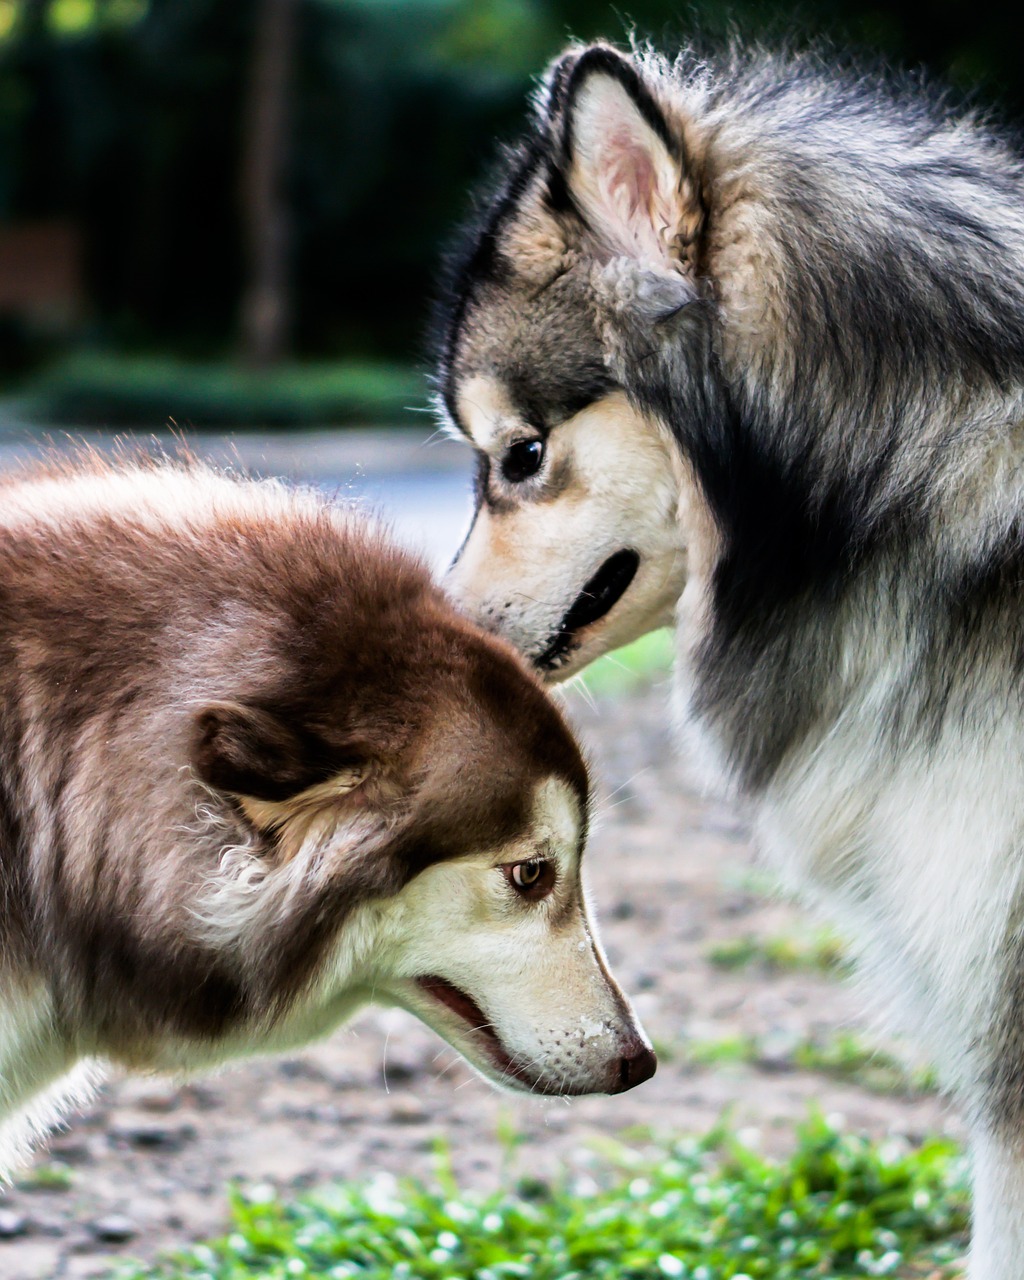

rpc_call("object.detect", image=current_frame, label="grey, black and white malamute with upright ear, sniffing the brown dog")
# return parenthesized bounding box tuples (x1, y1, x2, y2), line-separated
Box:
(440, 45, 1024, 1280)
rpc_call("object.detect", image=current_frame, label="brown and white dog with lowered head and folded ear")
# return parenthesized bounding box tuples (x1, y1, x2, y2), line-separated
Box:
(0, 463, 655, 1179)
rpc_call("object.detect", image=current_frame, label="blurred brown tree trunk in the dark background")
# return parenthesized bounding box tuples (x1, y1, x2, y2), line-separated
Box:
(239, 0, 300, 365)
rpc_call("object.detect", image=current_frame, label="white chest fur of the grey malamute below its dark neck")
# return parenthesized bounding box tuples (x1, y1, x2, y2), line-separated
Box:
(721, 670, 1024, 1088)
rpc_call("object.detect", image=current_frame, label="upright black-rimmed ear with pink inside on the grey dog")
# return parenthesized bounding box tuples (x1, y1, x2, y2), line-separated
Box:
(549, 45, 696, 271)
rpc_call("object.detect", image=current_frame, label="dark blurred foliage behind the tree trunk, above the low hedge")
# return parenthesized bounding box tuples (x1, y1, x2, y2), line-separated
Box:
(0, 0, 1024, 368)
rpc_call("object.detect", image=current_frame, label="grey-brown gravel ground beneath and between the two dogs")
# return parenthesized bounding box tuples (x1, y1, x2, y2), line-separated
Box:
(0, 684, 960, 1280)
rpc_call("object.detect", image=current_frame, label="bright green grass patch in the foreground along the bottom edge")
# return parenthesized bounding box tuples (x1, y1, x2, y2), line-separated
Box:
(118, 1117, 968, 1280)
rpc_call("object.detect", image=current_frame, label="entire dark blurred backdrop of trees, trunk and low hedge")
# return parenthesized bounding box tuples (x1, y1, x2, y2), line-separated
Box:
(0, 0, 1024, 426)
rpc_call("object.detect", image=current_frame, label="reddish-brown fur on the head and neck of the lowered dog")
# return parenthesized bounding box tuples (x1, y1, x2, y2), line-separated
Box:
(0, 462, 586, 1065)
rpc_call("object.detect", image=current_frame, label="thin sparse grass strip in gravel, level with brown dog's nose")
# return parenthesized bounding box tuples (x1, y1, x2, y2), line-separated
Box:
(684, 1032, 938, 1097)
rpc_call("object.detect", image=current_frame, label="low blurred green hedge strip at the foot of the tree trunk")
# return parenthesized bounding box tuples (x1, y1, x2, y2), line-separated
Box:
(24, 352, 428, 429)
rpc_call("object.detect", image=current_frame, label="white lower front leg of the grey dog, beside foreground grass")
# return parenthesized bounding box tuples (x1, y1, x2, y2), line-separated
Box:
(968, 1128, 1024, 1280)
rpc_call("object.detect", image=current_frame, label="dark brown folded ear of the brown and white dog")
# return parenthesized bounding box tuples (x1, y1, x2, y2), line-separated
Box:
(192, 701, 360, 801)
